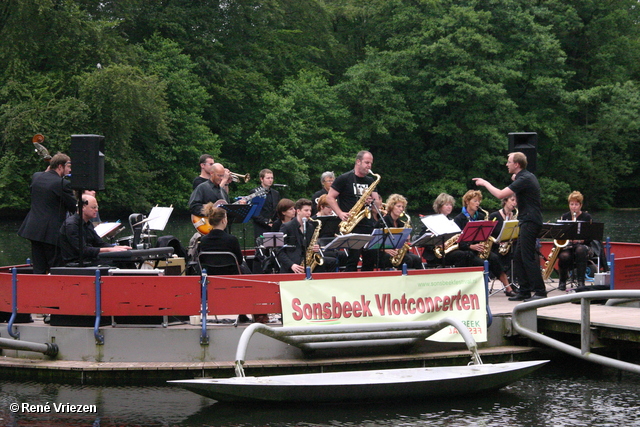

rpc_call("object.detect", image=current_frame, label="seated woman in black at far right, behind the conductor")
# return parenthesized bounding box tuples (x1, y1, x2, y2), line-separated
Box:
(558, 191, 593, 291)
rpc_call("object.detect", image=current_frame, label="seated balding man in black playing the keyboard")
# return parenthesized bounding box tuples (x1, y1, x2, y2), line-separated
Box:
(60, 194, 131, 264)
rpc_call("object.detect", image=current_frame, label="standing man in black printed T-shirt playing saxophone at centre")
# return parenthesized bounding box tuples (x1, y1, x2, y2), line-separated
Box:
(327, 151, 379, 271)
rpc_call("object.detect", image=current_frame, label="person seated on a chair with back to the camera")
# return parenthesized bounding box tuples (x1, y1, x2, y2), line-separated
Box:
(200, 203, 251, 274)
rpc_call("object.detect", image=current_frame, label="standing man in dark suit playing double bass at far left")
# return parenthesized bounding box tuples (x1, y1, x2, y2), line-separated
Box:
(18, 153, 76, 274)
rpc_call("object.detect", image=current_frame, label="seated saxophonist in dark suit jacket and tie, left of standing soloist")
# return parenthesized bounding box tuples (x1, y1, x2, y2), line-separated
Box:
(277, 199, 338, 273)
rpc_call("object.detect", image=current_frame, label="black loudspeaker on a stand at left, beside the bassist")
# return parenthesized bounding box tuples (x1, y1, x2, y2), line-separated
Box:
(70, 135, 104, 190)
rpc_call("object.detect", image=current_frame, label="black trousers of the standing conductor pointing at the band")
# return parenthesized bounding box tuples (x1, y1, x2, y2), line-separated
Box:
(513, 221, 547, 296)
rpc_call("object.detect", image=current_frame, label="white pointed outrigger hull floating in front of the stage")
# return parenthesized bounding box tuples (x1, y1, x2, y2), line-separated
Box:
(169, 360, 548, 402)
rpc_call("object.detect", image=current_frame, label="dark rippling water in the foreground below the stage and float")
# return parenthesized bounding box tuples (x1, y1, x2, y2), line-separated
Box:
(0, 361, 640, 427)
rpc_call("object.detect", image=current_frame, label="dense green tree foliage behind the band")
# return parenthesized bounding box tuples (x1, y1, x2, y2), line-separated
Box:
(0, 0, 640, 216)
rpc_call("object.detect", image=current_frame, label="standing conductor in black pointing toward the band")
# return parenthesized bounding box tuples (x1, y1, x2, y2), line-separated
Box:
(473, 151, 547, 301)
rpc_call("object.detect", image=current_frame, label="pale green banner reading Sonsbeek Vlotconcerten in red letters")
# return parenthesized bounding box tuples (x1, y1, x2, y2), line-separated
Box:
(280, 271, 487, 342)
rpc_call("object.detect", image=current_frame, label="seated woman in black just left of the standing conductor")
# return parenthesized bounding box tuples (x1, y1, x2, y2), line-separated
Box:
(445, 190, 516, 296)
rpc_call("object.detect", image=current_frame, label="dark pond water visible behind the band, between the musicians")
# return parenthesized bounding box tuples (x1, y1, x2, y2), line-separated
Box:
(0, 210, 640, 265)
